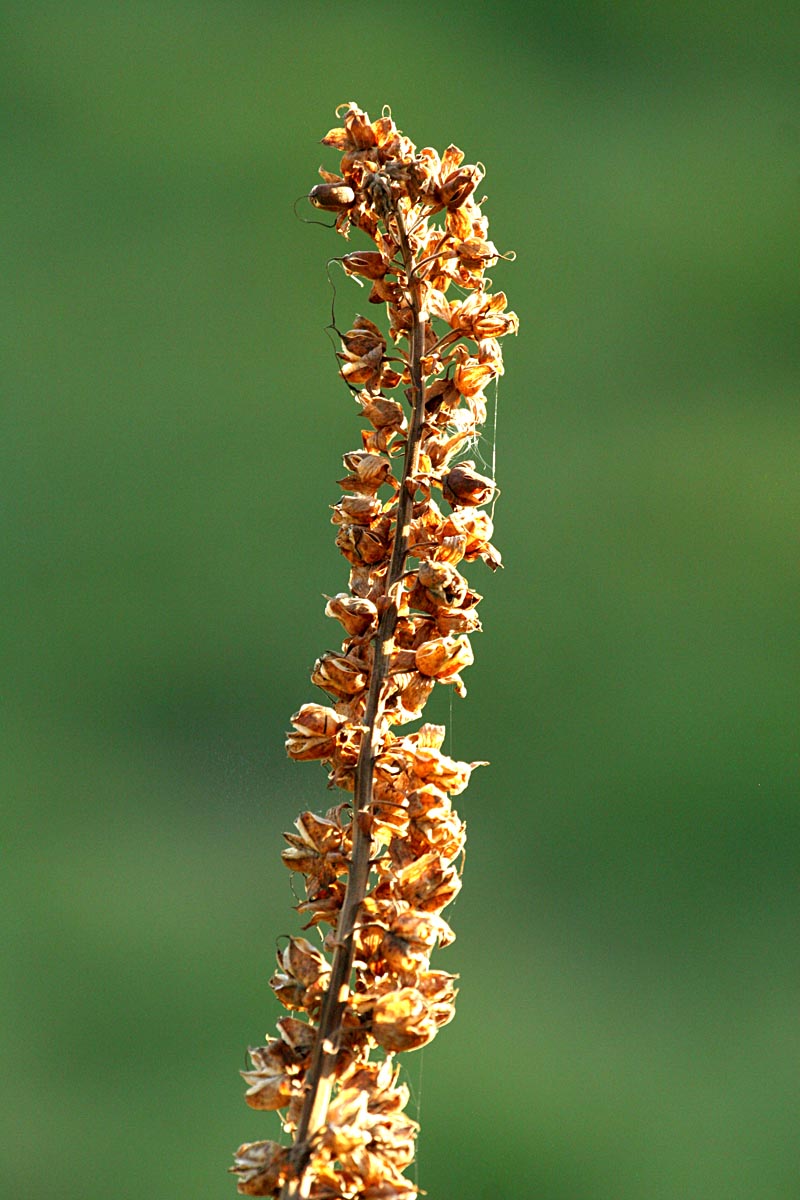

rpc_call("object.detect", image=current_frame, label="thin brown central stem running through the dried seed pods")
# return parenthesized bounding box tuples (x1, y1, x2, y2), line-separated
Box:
(281, 192, 426, 1200)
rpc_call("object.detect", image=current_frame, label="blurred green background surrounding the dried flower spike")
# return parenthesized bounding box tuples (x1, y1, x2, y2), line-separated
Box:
(0, 0, 800, 1200)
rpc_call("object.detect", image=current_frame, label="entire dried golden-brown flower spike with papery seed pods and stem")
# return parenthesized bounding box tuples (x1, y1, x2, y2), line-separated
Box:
(233, 103, 517, 1200)
